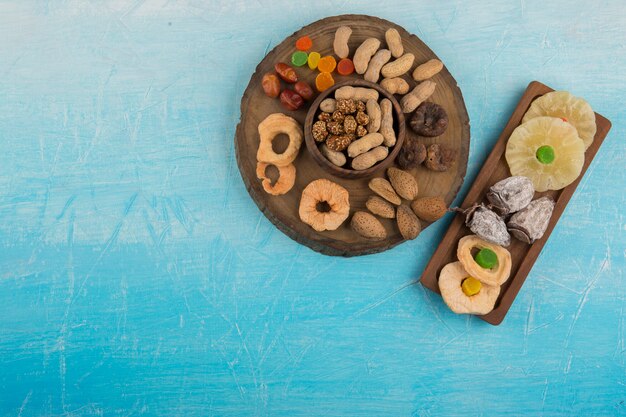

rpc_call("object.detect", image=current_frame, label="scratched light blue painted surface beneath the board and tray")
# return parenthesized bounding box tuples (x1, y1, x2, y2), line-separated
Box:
(0, 0, 626, 416)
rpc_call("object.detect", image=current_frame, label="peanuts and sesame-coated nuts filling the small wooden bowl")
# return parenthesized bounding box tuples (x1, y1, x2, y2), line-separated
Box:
(312, 86, 396, 171)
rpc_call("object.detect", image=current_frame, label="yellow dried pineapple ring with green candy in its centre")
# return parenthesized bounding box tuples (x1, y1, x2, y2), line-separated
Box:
(505, 117, 585, 192)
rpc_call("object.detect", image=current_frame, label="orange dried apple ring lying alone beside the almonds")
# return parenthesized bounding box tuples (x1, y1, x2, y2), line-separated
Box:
(298, 179, 350, 232)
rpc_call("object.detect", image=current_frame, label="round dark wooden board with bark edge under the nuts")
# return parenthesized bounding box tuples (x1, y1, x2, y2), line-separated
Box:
(235, 15, 470, 256)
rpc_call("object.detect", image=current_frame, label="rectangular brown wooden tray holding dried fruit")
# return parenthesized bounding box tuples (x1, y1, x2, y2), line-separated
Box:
(421, 81, 611, 325)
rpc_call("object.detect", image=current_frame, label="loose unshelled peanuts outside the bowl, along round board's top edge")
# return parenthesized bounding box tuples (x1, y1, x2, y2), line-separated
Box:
(333, 26, 443, 113)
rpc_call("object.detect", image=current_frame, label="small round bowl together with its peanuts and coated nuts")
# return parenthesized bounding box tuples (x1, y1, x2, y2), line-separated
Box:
(304, 79, 405, 178)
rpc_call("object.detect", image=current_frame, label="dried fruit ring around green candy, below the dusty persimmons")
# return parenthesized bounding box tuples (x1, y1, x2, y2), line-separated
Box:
(456, 235, 511, 286)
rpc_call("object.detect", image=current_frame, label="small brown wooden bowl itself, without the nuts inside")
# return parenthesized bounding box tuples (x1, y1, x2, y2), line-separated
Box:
(304, 80, 405, 178)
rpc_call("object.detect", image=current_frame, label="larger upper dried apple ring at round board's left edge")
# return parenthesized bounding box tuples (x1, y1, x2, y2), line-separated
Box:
(256, 113, 303, 167)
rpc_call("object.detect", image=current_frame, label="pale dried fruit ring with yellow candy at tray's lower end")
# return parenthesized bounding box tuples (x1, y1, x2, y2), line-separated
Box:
(439, 262, 500, 314)
